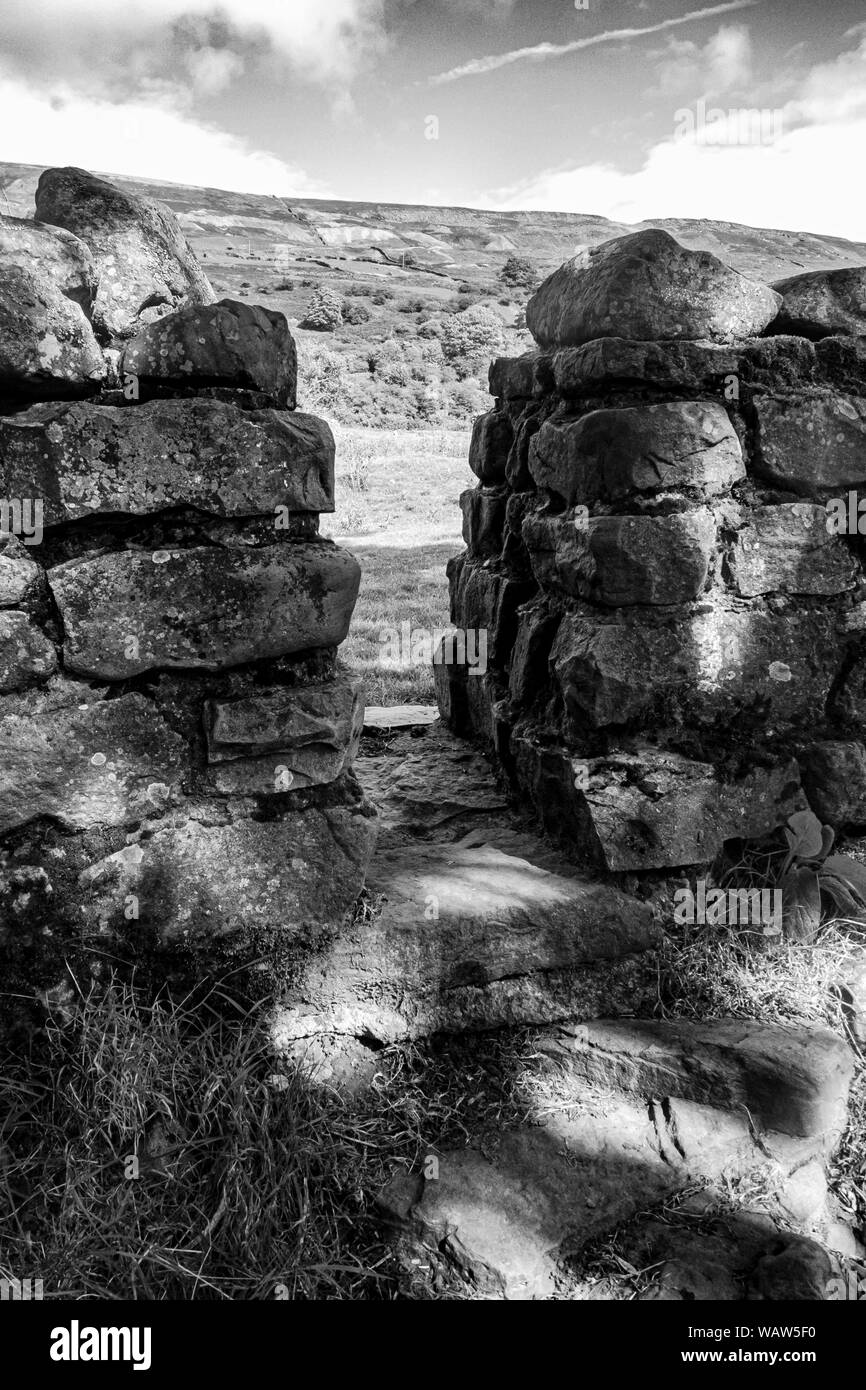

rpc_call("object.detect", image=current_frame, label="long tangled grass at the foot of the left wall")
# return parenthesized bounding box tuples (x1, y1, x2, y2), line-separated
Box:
(0, 981, 536, 1301)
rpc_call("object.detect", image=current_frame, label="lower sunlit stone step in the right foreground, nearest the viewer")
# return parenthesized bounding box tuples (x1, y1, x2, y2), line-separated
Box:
(379, 1019, 855, 1300)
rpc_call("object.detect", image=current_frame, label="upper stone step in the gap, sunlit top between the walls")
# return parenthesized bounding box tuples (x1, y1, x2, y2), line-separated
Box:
(274, 831, 659, 1047)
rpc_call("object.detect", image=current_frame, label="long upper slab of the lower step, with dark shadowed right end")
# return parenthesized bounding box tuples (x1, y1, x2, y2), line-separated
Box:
(542, 1019, 853, 1150)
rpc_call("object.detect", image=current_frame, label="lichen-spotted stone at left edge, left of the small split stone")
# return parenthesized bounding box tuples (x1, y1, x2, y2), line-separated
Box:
(0, 695, 185, 834)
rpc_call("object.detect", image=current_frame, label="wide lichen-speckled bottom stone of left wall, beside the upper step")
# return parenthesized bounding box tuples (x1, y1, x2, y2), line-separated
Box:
(79, 806, 375, 962)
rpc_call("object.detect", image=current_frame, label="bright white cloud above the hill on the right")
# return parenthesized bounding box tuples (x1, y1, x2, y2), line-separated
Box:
(481, 33, 866, 240)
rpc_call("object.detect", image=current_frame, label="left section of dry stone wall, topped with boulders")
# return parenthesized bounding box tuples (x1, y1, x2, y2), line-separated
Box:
(0, 170, 374, 1023)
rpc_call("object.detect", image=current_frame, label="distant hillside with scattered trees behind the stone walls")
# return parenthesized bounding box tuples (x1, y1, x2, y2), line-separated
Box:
(6, 163, 866, 428)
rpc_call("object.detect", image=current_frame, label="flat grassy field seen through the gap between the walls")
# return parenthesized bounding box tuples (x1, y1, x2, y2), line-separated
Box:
(321, 425, 477, 705)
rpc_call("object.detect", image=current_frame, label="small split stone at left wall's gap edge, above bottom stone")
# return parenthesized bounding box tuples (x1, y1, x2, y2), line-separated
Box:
(204, 680, 364, 795)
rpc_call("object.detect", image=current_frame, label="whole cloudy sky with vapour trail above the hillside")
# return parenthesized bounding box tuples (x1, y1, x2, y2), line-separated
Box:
(0, 0, 866, 240)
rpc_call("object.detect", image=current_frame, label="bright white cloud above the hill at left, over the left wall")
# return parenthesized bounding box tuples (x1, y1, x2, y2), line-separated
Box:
(0, 76, 332, 197)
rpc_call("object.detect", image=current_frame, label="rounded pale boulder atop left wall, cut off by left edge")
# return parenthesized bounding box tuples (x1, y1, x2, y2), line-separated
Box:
(0, 217, 106, 400)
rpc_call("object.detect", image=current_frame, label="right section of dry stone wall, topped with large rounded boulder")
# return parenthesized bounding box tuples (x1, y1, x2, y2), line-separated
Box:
(435, 229, 866, 872)
